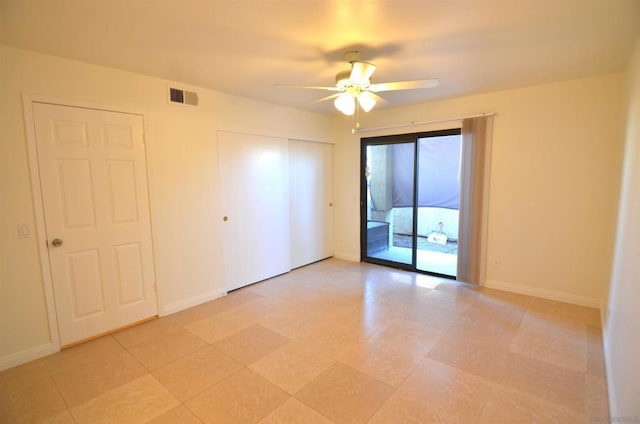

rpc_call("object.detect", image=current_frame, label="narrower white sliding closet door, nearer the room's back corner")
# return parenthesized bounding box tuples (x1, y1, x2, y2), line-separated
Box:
(289, 140, 333, 268)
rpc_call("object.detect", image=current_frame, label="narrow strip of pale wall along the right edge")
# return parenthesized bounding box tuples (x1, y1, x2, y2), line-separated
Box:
(604, 38, 640, 418)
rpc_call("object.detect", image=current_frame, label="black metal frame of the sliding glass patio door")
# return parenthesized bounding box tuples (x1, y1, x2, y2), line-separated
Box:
(360, 128, 461, 280)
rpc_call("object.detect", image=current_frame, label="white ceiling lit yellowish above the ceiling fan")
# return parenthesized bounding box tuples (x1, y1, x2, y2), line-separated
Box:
(0, 0, 640, 113)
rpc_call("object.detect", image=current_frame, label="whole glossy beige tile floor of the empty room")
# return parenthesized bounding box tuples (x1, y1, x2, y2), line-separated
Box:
(0, 259, 608, 424)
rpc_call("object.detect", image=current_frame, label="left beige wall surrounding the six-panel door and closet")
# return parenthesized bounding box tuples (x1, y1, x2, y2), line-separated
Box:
(0, 46, 335, 369)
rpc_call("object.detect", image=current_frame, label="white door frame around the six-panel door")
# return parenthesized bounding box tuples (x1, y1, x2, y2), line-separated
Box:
(22, 93, 159, 353)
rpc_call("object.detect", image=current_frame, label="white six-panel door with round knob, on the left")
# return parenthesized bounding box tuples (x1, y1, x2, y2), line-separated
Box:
(33, 103, 157, 345)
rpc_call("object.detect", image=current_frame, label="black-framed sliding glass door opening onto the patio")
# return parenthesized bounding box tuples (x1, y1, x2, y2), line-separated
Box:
(361, 129, 461, 278)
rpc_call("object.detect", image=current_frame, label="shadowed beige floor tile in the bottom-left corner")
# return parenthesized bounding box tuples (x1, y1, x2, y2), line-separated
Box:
(0, 361, 66, 424)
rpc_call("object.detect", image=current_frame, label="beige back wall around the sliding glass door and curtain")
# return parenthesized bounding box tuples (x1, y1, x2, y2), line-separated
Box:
(334, 74, 623, 306)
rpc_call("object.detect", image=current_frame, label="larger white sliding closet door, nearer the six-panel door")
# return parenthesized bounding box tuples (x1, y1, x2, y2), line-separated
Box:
(218, 131, 291, 291)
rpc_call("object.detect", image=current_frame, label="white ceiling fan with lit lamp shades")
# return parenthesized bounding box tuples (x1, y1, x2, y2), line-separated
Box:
(276, 51, 439, 115)
